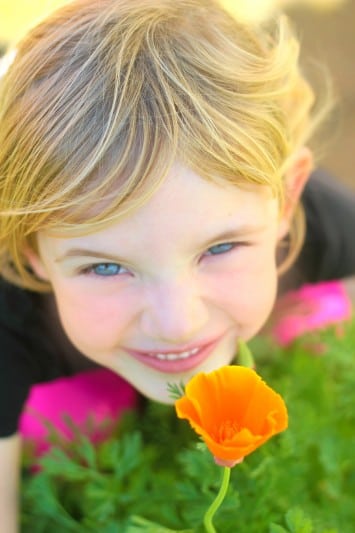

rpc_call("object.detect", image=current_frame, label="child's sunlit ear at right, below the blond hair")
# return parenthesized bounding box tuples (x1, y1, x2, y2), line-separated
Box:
(279, 146, 313, 240)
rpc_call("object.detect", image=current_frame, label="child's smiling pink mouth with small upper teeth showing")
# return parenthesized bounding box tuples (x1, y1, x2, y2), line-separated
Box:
(126, 337, 220, 374)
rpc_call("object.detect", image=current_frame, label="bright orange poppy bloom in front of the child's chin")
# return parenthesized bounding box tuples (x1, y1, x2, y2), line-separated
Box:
(175, 366, 288, 466)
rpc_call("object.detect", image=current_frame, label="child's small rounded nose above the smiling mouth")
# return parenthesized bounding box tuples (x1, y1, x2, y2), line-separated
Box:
(141, 280, 208, 344)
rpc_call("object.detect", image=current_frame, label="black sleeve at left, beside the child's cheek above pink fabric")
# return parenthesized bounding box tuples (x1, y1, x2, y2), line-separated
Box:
(0, 281, 99, 438)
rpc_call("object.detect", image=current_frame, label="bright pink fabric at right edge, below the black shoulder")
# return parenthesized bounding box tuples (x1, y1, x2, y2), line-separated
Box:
(272, 281, 352, 346)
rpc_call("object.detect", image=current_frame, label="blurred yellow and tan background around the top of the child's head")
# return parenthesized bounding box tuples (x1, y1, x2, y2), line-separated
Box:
(0, 0, 355, 189)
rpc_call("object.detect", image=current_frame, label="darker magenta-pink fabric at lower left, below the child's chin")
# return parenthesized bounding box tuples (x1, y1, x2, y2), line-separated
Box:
(20, 369, 137, 455)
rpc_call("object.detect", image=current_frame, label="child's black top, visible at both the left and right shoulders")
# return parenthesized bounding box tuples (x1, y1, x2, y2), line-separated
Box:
(0, 171, 355, 437)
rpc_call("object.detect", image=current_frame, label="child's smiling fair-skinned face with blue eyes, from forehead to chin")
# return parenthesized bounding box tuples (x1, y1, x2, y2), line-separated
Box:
(30, 166, 284, 402)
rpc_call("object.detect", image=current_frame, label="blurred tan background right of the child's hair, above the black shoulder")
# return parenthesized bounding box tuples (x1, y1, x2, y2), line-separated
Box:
(288, 0, 355, 189)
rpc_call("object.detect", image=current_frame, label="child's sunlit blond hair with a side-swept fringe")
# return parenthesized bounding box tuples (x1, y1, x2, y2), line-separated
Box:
(0, 0, 326, 290)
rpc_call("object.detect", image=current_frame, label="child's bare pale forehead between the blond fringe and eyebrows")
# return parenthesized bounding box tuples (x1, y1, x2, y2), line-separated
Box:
(42, 165, 278, 248)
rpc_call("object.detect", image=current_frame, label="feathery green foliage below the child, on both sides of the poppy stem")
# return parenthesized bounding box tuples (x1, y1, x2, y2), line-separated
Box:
(22, 318, 355, 533)
